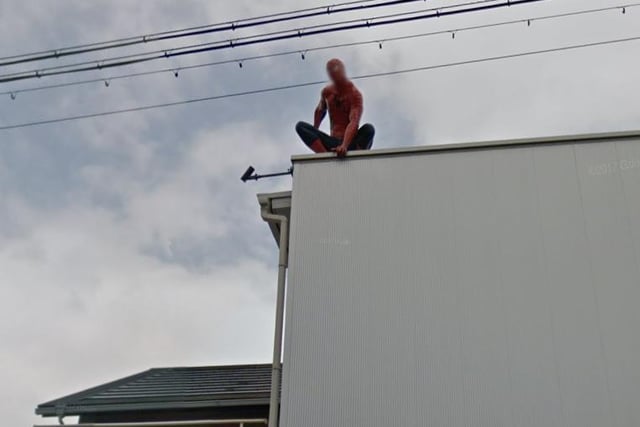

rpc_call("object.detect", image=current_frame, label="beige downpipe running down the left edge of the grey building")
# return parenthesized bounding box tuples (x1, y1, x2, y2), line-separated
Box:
(261, 207, 289, 427)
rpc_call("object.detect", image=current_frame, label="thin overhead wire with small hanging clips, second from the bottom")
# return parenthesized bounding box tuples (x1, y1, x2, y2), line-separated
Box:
(0, 3, 640, 97)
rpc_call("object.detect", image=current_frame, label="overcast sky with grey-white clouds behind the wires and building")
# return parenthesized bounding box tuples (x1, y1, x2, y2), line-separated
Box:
(0, 0, 640, 426)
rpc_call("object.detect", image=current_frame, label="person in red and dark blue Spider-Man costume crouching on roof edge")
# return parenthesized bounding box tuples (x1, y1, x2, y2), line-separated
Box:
(296, 59, 375, 157)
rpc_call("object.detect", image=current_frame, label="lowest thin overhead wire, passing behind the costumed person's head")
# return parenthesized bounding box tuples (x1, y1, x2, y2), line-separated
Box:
(0, 36, 640, 131)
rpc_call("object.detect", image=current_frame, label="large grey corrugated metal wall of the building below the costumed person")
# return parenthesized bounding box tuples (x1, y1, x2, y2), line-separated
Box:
(282, 141, 640, 427)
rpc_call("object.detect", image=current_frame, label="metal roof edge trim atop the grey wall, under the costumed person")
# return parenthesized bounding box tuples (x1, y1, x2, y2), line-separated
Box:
(291, 130, 640, 163)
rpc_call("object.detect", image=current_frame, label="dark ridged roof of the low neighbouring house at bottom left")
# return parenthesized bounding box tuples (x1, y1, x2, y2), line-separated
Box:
(36, 364, 271, 417)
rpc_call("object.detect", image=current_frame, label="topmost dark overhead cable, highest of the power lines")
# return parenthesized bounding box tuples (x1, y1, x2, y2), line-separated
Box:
(0, 0, 425, 66)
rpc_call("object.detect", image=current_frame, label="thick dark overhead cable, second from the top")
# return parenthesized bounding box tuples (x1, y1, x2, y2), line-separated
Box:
(0, 0, 545, 83)
